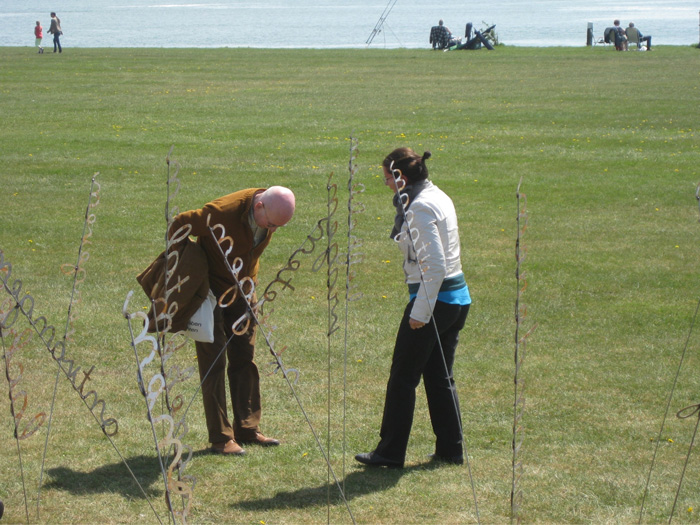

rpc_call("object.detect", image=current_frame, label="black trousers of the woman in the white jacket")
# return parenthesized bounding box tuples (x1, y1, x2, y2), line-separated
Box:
(375, 301, 469, 462)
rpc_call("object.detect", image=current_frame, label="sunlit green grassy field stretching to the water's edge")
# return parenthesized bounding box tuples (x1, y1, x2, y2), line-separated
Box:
(0, 46, 700, 524)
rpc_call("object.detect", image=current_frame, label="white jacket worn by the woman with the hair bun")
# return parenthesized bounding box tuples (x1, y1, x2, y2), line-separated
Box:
(398, 181, 462, 323)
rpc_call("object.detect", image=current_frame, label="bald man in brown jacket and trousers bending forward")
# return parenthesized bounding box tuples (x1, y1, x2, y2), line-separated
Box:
(170, 186, 295, 456)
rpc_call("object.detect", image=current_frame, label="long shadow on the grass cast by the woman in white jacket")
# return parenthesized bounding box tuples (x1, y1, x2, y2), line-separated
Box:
(231, 464, 440, 511)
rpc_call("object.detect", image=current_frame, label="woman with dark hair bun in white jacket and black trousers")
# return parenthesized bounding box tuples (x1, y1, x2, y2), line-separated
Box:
(355, 148, 471, 468)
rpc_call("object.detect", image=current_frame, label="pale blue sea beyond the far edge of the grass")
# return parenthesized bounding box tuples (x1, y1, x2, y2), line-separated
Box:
(0, 0, 700, 49)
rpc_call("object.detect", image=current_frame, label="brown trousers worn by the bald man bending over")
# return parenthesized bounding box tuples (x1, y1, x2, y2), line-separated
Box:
(196, 300, 261, 443)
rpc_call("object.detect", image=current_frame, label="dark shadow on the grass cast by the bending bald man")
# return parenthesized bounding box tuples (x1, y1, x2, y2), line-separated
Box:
(44, 455, 163, 499)
